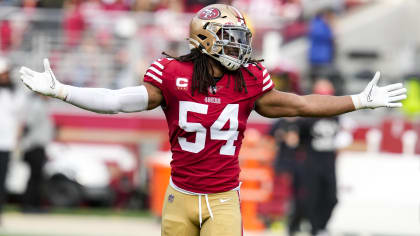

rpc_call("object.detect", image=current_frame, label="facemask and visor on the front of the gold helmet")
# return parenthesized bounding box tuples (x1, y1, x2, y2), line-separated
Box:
(200, 22, 252, 71)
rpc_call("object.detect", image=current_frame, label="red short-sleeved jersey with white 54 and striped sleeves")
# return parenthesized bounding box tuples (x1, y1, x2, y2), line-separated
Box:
(144, 59, 274, 193)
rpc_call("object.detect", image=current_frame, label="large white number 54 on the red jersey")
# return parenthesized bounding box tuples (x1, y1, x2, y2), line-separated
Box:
(178, 101, 239, 155)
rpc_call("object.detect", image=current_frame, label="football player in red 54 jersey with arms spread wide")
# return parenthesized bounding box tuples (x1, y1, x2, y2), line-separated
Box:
(20, 4, 406, 236)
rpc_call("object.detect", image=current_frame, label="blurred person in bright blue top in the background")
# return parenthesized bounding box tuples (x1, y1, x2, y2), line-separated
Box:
(308, 8, 336, 82)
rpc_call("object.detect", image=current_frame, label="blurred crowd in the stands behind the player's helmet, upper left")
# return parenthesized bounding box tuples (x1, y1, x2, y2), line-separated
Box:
(0, 0, 361, 88)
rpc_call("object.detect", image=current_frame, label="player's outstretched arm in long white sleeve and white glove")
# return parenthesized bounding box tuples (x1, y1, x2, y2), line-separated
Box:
(20, 59, 163, 114)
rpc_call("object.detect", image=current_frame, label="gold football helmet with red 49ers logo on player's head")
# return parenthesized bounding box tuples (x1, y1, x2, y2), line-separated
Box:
(189, 4, 252, 70)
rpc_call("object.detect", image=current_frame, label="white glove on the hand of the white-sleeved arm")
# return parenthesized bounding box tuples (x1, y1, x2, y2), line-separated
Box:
(19, 58, 68, 100)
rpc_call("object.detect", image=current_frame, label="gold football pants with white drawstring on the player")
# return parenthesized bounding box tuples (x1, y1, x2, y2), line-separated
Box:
(161, 186, 242, 236)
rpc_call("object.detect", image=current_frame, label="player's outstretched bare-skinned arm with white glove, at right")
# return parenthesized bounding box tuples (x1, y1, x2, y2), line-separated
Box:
(256, 72, 407, 118)
